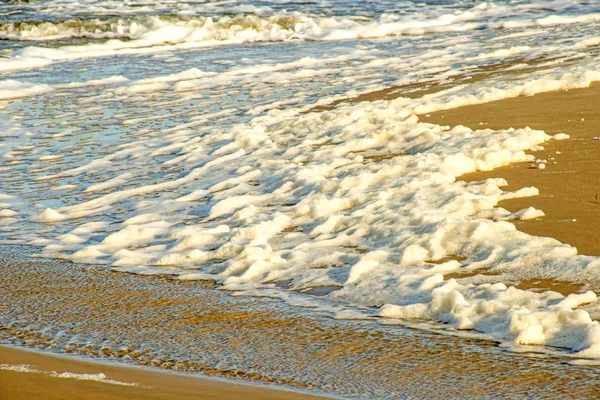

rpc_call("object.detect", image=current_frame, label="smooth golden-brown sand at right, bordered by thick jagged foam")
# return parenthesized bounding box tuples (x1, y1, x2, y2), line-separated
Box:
(419, 84, 600, 255)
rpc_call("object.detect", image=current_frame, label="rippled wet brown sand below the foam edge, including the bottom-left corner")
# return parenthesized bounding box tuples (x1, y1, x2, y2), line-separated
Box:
(0, 246, 600, 399)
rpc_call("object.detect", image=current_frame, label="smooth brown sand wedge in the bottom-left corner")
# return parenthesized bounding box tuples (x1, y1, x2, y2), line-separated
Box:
(0, 346, 323, 400)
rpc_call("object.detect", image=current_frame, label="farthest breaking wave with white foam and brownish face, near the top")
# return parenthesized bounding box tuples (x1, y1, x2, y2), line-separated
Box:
(0, 3, 600, 42)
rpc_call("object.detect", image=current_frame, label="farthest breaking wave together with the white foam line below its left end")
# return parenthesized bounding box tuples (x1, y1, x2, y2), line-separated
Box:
(0, 4, 600, 71)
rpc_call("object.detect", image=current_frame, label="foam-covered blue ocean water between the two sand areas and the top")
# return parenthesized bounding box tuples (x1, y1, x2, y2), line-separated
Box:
(0, 0, 600, 390)
